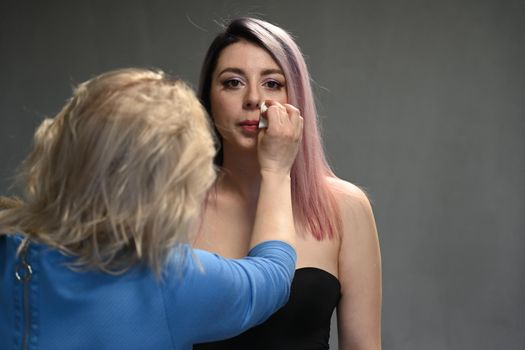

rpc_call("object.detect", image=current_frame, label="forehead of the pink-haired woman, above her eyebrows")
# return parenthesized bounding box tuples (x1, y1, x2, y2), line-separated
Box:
(217, 40, 279, 71)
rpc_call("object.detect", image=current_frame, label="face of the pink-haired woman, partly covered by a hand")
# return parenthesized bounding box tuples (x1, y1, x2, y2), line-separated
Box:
(210, 40, 287, 150)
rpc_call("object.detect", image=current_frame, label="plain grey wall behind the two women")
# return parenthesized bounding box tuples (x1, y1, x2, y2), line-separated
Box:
(0, 0, 525, 350)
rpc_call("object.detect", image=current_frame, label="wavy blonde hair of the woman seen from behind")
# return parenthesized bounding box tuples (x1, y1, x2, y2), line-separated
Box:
(0, 69, 215, 274)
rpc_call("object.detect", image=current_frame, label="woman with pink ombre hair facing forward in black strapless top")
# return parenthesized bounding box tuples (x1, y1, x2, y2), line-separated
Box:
(194, 18, 381, 350)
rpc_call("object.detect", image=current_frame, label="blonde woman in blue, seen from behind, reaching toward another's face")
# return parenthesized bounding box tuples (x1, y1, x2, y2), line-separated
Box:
(0, 69, 302, 349)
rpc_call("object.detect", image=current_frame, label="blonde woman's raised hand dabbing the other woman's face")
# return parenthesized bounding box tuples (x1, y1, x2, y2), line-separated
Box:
(257, 100, 303, 174)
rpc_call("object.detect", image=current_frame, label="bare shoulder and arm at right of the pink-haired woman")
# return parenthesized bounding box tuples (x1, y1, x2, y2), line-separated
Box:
(328, 178, 381, 349)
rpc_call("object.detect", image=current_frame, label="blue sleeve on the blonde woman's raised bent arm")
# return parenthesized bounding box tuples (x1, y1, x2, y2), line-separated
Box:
(163, 241, 296, 346)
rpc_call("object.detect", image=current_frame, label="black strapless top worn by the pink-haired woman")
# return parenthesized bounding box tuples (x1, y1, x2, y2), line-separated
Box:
(193, 267, 341, 350)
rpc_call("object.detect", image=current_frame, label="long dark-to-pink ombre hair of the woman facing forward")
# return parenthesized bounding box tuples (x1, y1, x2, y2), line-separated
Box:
(198, 17, 342, 240)
